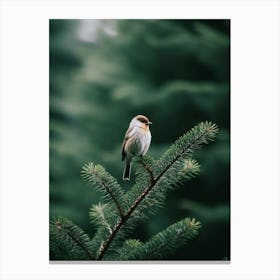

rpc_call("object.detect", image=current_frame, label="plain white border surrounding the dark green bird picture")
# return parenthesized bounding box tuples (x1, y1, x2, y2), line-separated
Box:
(0, 0, 280, 280)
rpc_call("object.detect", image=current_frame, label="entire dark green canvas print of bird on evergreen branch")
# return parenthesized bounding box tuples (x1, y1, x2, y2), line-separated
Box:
(49, 19, 230, 262)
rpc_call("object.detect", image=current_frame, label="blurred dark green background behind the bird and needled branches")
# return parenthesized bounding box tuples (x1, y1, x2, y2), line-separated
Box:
(50, 20, 230, 260)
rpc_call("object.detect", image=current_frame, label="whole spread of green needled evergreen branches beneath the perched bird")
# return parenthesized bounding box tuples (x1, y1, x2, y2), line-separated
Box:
(50, 122, 218, 260)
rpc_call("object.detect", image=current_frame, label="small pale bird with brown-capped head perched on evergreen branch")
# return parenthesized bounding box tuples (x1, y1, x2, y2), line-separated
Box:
(122, 115, 152, 181)
